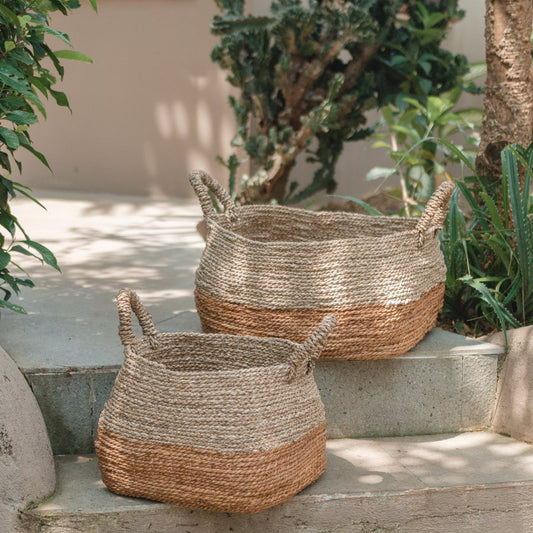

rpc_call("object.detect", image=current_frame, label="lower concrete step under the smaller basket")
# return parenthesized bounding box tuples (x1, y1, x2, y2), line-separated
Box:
(21, 432, 533, 533)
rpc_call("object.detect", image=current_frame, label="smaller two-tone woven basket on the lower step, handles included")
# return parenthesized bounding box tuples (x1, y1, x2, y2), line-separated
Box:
(95, 289, 335, 513)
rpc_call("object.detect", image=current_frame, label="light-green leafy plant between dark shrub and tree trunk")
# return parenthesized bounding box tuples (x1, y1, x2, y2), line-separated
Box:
(366, 63, 486, 216)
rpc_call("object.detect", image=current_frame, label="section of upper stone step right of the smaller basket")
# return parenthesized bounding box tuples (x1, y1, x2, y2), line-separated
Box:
(315, 329, 503, 438)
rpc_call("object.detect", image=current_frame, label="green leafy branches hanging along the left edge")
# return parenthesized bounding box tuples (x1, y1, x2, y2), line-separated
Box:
(0, 0, 96, 313)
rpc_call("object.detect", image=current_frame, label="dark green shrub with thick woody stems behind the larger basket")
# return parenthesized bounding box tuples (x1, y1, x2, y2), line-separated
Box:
(212, 0, 467, 203)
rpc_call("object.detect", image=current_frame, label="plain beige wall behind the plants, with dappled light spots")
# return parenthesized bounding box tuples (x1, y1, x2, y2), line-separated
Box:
(18, 0, 484, 200)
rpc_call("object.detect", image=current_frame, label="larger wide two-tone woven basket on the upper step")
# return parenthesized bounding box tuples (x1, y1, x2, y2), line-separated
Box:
(190, 171, 454, 359)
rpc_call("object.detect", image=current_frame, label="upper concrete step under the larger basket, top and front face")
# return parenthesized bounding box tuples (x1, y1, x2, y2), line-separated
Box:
(0, 193, 502, 454)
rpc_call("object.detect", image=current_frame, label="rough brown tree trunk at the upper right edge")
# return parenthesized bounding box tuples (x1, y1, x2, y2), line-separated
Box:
(476, 0, 533, 181)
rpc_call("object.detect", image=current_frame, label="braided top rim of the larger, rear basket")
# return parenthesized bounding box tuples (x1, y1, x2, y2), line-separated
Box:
(205, 205, 435, 248)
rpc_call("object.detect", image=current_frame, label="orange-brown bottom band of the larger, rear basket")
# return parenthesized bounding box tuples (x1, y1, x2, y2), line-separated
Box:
(194, 283, 444, 360)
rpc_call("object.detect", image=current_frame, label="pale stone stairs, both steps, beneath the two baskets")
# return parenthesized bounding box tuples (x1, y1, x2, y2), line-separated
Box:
(0, 195, 533, 533)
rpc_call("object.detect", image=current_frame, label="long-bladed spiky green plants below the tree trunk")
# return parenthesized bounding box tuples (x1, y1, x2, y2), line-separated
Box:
(441, 144, 533, 335)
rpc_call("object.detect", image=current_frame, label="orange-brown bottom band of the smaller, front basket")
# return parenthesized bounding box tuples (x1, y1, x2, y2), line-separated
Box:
(95, 422, 326, 513)
